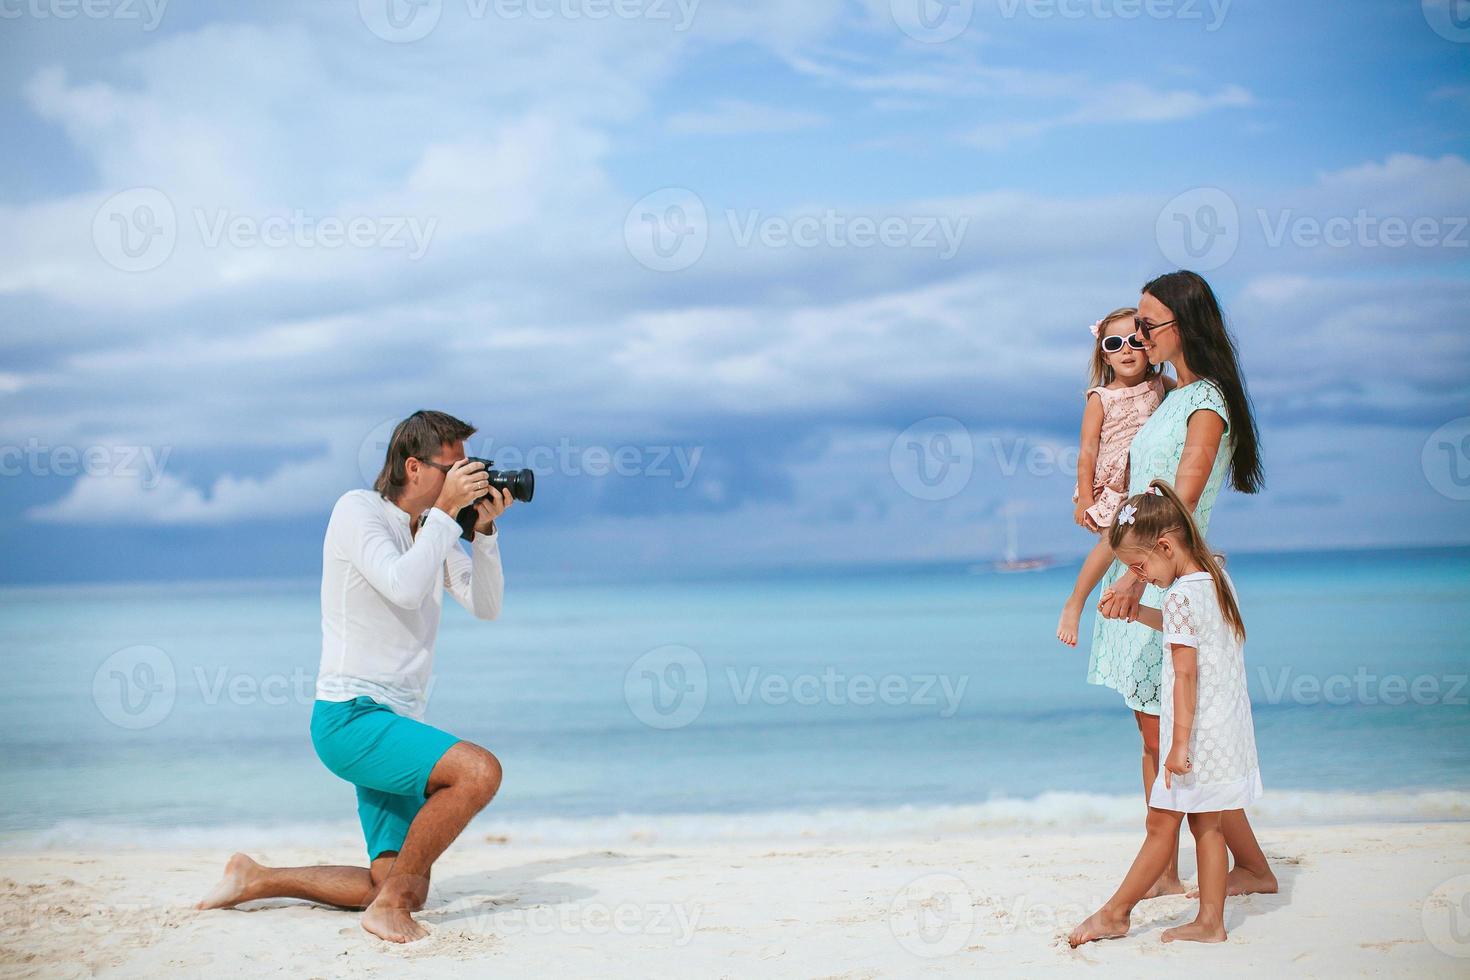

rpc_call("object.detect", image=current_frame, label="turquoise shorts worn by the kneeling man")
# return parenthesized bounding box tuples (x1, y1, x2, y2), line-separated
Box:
(312, 696, 459, 861)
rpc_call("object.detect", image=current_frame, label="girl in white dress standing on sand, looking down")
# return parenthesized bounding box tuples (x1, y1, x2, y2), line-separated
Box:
(1069, 480, 1264, 946)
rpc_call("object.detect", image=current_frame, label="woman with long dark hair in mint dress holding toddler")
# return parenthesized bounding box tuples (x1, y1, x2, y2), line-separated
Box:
(1088, 272, 1276, 895)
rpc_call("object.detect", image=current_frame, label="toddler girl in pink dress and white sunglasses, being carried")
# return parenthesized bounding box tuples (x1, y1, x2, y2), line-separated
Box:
(1057, 307, 1169, 646)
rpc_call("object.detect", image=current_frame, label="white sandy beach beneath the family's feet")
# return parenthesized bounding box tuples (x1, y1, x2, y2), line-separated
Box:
(0, 823, 1470, 977)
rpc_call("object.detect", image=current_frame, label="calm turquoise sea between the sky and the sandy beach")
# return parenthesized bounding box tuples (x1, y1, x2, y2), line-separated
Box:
(0, 548, 1470, 846)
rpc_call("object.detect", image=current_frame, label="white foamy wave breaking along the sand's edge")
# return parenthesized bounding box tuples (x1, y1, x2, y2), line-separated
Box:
(0, 789, 1470, 852)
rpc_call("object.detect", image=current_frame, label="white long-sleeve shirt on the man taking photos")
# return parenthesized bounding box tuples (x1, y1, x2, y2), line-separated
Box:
(316, 489, 506, 718)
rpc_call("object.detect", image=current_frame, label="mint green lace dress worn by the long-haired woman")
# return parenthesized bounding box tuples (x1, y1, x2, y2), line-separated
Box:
(1088, 379, 1233, 714)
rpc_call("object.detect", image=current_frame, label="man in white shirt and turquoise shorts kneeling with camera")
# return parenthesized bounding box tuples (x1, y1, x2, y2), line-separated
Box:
(198, 411, 512, 943)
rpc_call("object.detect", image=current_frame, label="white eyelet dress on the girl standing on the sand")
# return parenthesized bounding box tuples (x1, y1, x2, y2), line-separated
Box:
(1148, 572, 1266, 814)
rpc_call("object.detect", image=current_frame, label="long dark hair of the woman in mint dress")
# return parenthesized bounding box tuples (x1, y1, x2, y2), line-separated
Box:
(1144, 272, 1266, 494)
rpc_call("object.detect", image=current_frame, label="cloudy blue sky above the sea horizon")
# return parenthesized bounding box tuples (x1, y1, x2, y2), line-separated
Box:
(0, 0, 1470, 582)
